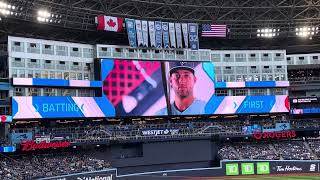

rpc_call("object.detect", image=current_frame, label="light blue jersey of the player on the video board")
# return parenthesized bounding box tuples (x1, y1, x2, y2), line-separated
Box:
(156, 99, 207, 116)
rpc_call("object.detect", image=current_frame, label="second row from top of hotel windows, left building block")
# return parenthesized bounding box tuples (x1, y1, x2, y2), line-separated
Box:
(10, 58, 93, 71)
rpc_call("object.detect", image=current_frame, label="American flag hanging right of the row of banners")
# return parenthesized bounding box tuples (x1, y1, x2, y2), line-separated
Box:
(201, 24, 227, 37)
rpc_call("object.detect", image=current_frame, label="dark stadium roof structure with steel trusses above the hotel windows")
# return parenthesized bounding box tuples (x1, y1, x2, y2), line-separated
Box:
(0, 0, 320, 51)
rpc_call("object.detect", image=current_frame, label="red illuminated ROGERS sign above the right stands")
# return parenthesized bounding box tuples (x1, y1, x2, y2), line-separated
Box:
(253, 130, 297, 140)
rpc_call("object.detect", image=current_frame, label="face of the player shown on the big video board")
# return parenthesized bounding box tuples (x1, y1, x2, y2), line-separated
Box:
(170, 70, 196, 98)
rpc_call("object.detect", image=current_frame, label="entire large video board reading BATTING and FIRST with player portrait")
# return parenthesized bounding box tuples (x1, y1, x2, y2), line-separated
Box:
(12, 59, 289, 119)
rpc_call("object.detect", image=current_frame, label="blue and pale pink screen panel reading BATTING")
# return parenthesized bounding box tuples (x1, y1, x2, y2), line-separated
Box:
(12, 96, 115, 119)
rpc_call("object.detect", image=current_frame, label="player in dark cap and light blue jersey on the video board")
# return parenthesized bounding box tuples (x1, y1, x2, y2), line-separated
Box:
(156, 62, 206, 115)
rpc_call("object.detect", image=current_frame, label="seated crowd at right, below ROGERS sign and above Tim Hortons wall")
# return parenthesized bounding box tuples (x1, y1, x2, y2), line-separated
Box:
(218, 140, 320, 160)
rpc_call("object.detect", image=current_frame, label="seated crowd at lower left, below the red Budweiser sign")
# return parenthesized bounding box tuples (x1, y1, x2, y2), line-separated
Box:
(0, 152, 111, 180)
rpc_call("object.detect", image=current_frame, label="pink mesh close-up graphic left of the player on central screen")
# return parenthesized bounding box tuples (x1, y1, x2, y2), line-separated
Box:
(101, 59, 166, 116)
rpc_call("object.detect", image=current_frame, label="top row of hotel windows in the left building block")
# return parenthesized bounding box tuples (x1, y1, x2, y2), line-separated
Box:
(11, 41, 94, 58)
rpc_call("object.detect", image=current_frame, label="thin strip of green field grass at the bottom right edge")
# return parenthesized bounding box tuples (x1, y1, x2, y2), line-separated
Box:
(224, 175, 320, 180)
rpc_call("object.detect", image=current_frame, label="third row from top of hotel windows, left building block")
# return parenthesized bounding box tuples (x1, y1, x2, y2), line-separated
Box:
(11, 69, 94, 80)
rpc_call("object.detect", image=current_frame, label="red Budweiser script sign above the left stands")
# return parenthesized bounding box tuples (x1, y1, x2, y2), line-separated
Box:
(22, 141, 70, 151)
